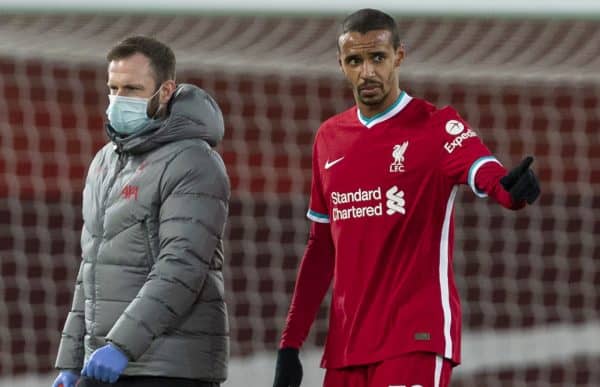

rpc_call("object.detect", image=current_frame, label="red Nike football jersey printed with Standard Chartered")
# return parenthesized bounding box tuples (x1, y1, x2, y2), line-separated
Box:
(308, 92, 498, 368)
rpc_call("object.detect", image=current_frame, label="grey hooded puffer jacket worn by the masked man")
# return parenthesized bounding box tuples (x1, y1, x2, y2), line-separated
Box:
(56, 84, 230, 382)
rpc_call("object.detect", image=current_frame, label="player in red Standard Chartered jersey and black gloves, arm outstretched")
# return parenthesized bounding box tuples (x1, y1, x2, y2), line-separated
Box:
(274, 9, 540, 387)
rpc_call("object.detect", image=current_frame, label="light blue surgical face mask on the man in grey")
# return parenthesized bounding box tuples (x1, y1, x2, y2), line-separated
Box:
(106, 89, 160, 135)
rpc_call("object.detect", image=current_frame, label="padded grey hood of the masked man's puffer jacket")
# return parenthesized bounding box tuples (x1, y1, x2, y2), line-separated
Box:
(106, 83, 225, 154)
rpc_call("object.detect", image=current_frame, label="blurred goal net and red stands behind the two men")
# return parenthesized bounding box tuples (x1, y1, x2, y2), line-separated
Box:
(0, 0, 600, 387)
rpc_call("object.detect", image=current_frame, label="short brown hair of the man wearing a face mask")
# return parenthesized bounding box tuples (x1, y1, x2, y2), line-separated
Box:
(106, 36, 175, 85)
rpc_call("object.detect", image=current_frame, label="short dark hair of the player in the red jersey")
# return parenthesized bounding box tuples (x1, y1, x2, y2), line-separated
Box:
(337, 8, 400, 49)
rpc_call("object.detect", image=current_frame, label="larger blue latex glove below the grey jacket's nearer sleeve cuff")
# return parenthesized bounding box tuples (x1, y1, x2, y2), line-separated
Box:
(81, 344, 129, 383)
